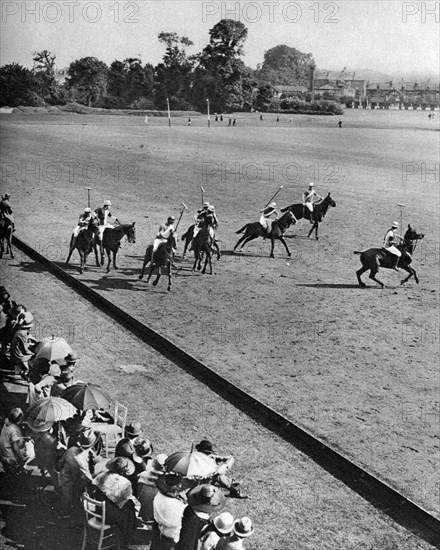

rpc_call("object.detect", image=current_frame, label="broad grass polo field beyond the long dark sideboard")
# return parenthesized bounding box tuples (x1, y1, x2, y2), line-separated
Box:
(1, 111, 440, 536)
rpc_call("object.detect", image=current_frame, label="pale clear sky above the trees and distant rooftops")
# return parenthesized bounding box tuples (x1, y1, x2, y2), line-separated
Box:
(0, 0, 440, 79)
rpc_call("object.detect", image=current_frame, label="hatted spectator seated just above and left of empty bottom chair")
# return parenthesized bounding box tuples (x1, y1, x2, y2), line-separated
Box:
(58, 428, 98, 509)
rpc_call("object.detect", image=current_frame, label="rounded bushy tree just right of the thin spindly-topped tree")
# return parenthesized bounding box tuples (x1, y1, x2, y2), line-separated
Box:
(67, 57, 108, 107)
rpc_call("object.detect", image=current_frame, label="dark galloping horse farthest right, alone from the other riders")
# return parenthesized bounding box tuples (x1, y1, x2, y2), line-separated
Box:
(354, 225, 425, 288)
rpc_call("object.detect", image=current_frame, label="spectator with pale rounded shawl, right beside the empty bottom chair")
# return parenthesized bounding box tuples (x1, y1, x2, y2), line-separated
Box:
(93, 457, 136, 550)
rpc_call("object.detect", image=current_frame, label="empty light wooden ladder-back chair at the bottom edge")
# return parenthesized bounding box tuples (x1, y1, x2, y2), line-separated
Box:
(81, 493, 121, 550)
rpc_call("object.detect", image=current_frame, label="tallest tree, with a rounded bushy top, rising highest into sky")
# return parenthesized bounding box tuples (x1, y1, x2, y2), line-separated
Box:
(193, 19, 251, 112)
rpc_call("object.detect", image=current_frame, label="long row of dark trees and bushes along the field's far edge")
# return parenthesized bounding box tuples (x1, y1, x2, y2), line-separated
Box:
(0, 19, 340, 113)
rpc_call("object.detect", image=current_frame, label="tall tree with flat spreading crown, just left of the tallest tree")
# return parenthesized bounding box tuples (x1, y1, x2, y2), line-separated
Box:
(155, 32, 195, 109)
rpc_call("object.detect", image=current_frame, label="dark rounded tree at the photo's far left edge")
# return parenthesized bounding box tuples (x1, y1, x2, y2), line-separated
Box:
(0, 63, 44, 107)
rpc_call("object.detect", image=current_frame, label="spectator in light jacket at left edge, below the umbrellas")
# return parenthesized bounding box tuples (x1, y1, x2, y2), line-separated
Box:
(0, 407, 27, 474)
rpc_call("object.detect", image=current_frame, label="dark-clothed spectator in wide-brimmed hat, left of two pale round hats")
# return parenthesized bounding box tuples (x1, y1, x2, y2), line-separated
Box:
(177, 485, 225, 550)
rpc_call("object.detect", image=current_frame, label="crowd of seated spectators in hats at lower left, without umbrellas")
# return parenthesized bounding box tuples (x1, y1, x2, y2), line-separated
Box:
(0, 287, 254, 550)
